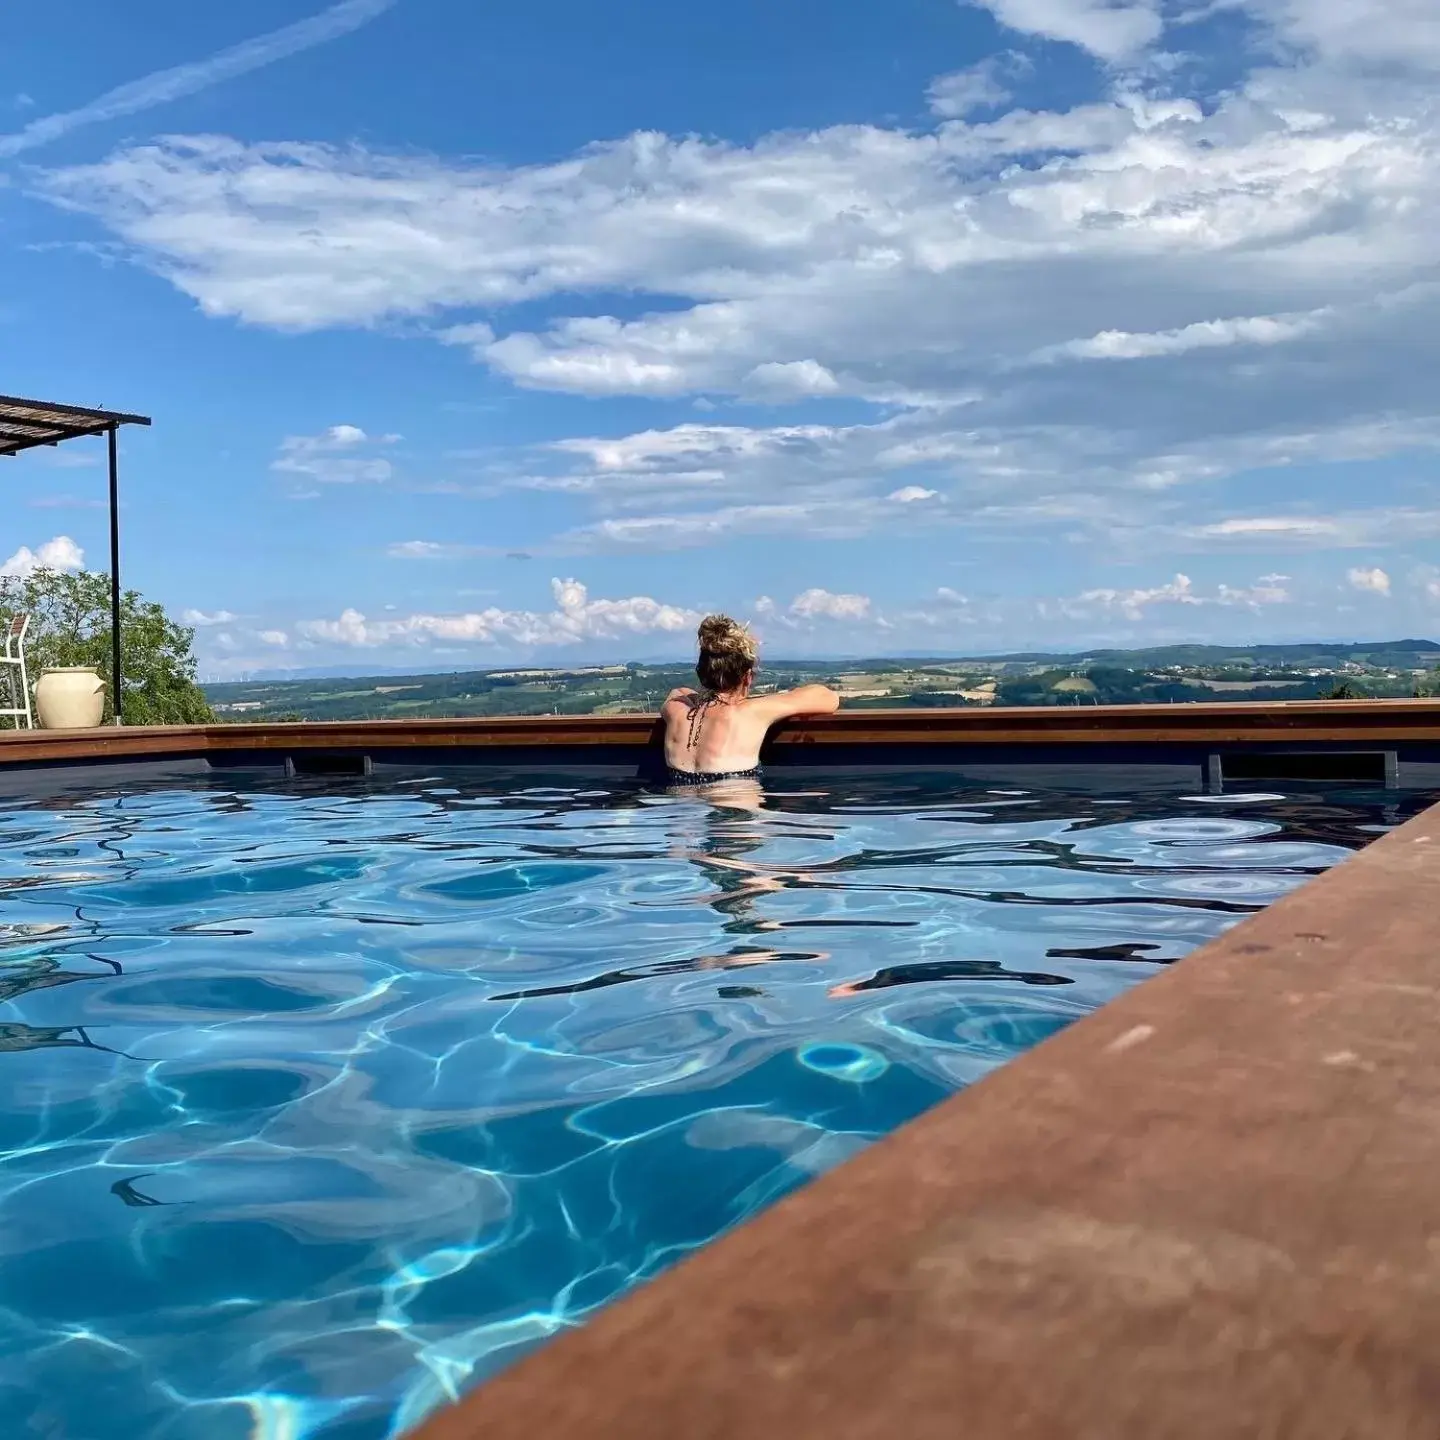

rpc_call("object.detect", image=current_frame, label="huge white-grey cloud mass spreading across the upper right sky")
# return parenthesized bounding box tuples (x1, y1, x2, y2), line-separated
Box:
(28, 0, 1440, 561)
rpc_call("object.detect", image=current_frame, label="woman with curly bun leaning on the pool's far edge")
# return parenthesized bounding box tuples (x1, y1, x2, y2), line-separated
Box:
(661, 615, 840, 785)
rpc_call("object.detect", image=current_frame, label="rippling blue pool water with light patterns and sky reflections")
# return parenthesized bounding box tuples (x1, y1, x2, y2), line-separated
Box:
(0, 776, 1420, 1440)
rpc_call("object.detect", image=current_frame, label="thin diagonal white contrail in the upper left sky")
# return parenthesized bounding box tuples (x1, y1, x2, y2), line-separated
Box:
(0, 0, 397, 160)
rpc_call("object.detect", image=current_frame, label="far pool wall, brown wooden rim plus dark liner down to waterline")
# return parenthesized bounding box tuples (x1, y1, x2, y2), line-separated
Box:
(0, 700, 1440, 793)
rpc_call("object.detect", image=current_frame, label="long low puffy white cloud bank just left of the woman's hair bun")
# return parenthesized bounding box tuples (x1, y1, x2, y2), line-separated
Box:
(295, 579, 701, 648)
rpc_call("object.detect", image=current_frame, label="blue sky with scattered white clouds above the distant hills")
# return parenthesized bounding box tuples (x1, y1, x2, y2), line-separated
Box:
(0, 0, 1440, 677)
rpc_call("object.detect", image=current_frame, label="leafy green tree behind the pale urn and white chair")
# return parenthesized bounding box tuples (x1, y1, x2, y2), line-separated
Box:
(0, 570, 215, 724)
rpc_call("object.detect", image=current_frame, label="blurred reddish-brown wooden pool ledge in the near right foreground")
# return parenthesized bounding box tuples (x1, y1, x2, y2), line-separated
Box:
(418, 808, 1440, 1440)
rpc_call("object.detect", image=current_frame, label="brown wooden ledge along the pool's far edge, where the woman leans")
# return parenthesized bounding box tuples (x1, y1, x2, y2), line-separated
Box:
(0, 700, 1440, 765)
